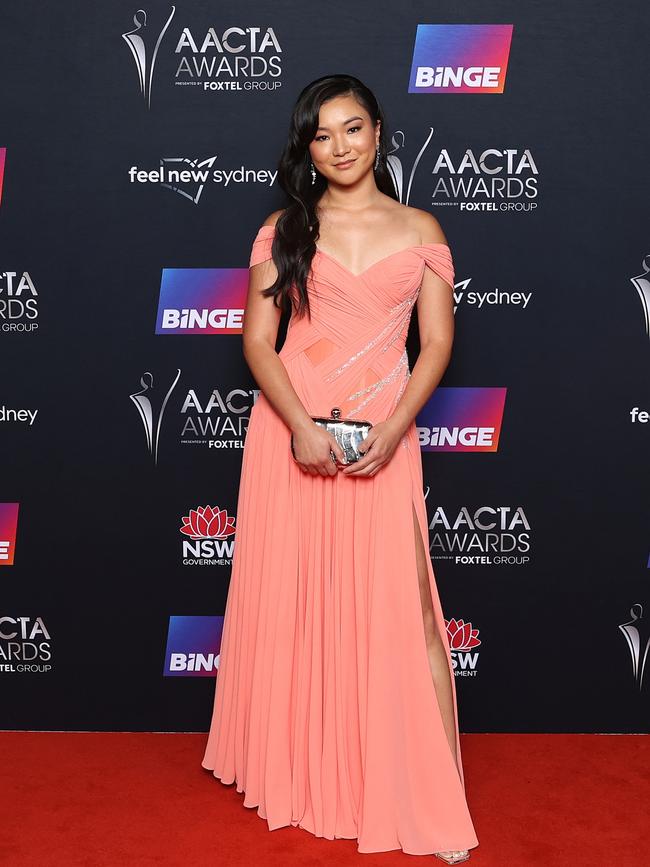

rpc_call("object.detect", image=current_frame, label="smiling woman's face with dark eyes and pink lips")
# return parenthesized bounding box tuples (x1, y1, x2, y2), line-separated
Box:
(309, 96, 380, 184)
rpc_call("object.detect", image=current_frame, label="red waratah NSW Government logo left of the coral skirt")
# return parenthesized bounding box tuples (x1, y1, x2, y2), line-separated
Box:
(180, 506, 235, 566)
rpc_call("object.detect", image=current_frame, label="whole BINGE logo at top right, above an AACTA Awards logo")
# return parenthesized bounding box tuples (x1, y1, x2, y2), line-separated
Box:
(408, 24, 513, 93)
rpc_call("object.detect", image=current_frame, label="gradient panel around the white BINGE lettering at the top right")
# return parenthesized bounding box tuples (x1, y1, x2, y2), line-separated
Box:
(408, 24, 512, 93)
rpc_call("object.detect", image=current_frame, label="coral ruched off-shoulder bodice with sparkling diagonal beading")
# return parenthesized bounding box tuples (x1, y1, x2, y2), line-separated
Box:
(250, 226, 454, 421)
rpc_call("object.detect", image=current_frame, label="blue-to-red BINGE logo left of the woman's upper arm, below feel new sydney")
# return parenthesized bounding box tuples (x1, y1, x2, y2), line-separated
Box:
(156, 268, 248, 334)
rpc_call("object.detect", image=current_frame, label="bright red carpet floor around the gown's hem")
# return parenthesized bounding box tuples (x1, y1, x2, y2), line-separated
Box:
(0, 732, 650, 867)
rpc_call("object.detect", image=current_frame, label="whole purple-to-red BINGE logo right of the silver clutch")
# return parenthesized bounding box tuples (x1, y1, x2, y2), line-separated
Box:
(417, 388, 507, 452)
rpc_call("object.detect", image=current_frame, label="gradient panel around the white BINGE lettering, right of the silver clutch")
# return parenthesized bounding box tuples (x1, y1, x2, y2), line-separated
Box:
(416, 387, 507, 452)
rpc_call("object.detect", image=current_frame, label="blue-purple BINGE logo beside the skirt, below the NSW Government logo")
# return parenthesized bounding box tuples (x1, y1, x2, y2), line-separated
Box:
(163, 615, 223, 677)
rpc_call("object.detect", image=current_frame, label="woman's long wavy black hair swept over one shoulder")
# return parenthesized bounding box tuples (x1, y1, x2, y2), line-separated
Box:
(262, 75, 398, 318)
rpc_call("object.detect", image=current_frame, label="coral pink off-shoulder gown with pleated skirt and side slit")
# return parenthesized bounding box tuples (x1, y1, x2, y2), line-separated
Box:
(201, 226, 478, 855)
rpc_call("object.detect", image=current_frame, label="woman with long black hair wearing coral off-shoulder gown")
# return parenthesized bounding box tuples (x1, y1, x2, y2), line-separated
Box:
(202, 76, 478, 863)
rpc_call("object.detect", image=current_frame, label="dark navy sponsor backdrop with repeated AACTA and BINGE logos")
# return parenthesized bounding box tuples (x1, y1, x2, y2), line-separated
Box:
(0, 0, 650, 732)
